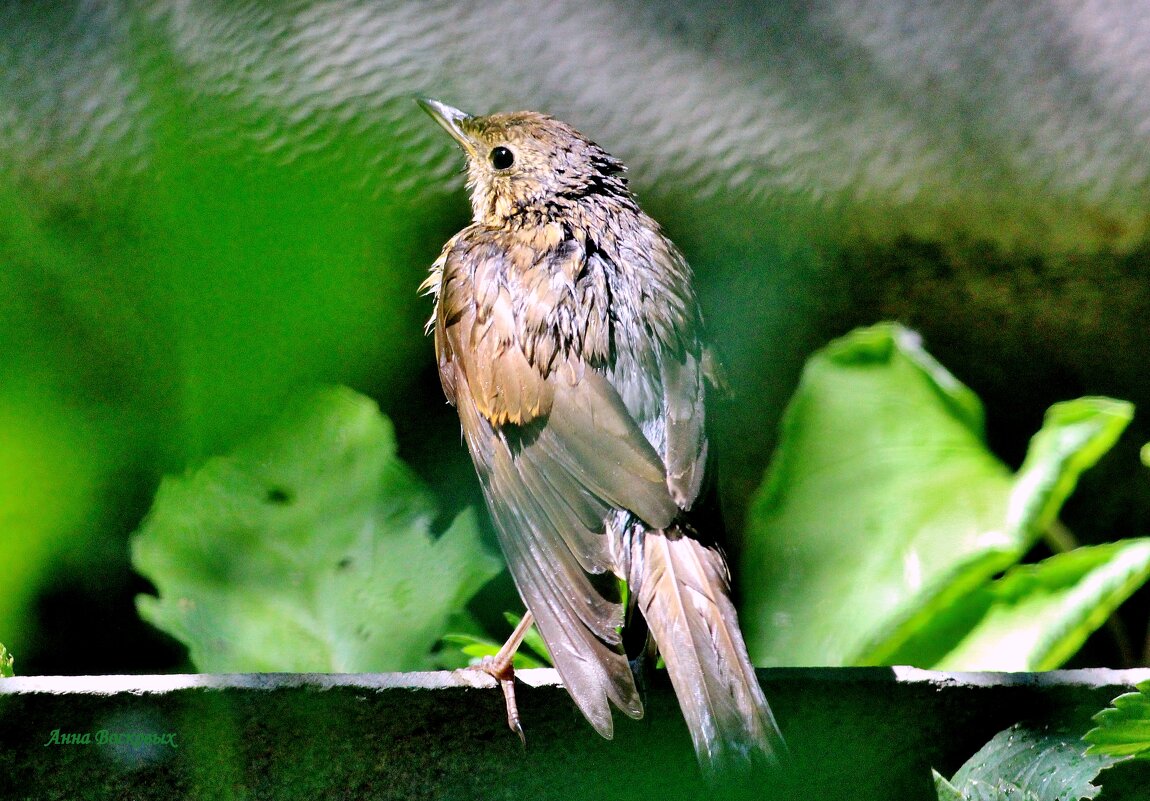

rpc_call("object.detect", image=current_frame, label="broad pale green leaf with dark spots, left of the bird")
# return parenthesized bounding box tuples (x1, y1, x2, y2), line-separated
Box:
(132, 388, 500, 672)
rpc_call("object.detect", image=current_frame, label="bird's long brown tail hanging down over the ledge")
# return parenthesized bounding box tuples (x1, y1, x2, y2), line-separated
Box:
(631, 524, 785, 778)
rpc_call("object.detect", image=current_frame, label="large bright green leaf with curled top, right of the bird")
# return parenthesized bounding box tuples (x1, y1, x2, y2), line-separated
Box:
(739, 324, 1132, 665)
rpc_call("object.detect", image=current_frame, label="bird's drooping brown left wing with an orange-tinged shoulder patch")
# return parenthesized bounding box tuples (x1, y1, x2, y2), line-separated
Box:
(436, 244, 679, 737)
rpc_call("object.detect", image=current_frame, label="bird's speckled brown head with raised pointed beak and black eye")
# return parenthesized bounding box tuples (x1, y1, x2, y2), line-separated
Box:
(419, 98, 628, 225)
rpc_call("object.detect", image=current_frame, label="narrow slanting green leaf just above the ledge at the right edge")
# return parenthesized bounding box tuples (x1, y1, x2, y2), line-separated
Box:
(891, 539, 1150, 671)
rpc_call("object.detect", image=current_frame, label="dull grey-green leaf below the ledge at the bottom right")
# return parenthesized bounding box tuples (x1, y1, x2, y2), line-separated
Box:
(936, 726, 1114, 801)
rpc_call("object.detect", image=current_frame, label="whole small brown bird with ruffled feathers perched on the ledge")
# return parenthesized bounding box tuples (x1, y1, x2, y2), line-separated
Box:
(419, 99, 783, 773)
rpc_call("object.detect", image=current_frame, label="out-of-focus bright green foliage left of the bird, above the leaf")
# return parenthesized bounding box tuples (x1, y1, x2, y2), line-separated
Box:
(0, 46, 466, 672)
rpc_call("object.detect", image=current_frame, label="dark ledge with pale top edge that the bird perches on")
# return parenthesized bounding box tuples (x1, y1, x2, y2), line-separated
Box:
(0, 668, 1150, 801)
